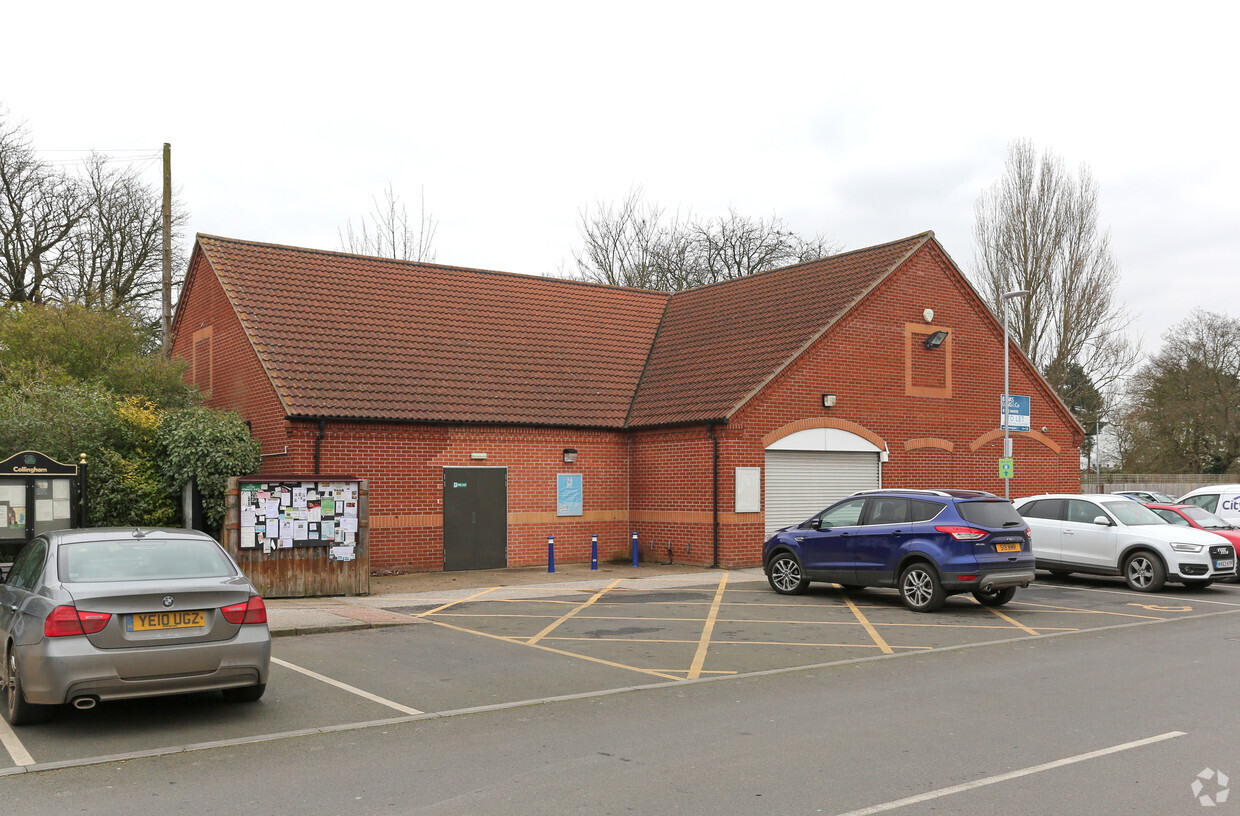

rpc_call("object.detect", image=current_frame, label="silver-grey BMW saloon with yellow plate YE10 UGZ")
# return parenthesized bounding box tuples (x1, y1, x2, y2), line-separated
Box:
(0, 528, 272, 725)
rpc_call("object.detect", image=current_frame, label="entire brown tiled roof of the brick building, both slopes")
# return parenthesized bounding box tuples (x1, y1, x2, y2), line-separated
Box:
(188, 233, 931, 428)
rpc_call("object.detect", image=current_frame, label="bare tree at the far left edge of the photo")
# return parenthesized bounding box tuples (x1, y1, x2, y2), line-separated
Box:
(0, 113, 89, 303)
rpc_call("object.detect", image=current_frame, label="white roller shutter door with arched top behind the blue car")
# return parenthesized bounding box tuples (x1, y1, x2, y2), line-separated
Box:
(765, 450, 882, 537)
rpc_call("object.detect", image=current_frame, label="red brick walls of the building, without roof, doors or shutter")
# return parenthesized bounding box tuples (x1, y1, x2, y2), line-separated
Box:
(174, 243, 1080, 570)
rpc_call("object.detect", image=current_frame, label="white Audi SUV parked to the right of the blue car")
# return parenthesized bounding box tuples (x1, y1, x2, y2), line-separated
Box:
(1016, 494, 1236, 592)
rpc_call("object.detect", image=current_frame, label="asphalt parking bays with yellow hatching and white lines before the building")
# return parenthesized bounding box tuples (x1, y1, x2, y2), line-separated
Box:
(0, 570, 1240, 774)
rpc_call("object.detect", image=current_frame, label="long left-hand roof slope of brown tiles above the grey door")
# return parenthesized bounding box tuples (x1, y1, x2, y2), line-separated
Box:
(198, 236, 668, 428)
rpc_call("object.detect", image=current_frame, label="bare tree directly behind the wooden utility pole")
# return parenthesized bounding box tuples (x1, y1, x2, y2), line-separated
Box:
(48, 154, 186, 311)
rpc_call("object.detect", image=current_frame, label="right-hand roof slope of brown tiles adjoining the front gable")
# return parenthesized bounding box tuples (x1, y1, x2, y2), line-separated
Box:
(629, 233, 932, 425)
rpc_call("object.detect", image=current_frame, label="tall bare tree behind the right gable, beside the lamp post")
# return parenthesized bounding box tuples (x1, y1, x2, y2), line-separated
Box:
(972, 141, 1138, 414)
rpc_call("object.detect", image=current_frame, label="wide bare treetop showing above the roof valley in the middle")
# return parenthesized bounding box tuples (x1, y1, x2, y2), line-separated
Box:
(574, 188, 839, 291)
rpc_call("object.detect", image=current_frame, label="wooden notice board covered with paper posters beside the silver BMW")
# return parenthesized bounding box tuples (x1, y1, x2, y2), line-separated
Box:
(223, 475, 370, 598)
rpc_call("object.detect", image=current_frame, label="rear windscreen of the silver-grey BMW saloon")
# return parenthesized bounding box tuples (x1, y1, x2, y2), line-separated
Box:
(56, 538, 237, 583)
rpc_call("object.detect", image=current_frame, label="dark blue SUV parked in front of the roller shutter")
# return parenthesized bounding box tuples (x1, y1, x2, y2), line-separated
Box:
(763, 490, 1034, 611)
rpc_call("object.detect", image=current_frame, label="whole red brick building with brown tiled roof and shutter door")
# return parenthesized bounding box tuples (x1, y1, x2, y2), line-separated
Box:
(174, 232, 1083, 570)
